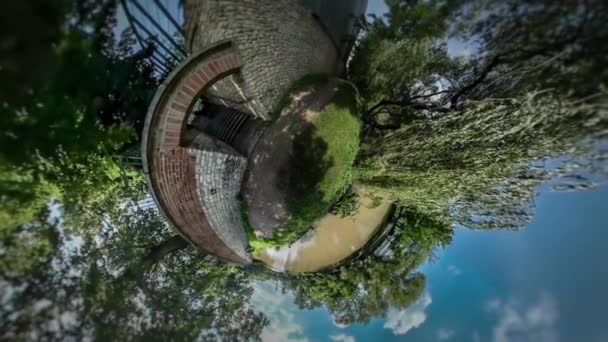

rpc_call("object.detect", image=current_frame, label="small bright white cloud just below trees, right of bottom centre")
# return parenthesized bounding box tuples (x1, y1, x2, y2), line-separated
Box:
(384, 292, 432, 335)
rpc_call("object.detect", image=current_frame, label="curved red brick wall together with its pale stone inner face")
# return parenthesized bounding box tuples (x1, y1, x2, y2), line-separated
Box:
(142, 43, 251, 263)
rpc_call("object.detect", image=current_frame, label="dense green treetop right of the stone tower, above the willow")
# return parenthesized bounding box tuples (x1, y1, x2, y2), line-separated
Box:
(349, 1, 453, 106)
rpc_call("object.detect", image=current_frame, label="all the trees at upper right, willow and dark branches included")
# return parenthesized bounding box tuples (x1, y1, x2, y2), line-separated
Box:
(351, 1, 608, 229)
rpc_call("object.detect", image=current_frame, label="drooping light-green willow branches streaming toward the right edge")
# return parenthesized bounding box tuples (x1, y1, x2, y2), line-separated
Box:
(355, 93, 608, 228)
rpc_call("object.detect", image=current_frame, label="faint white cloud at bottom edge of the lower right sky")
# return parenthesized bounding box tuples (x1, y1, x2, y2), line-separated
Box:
(486, 293, 559, 342)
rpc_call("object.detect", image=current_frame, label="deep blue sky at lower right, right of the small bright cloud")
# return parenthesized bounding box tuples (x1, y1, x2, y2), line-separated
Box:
(416, 186, 608, 341)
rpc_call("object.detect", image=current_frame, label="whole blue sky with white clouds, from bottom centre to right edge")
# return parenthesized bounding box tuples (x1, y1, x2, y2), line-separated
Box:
(253, 186, 608, 342)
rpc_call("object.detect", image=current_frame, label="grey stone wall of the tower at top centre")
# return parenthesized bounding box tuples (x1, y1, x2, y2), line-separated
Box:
(184, 0, 342, 118)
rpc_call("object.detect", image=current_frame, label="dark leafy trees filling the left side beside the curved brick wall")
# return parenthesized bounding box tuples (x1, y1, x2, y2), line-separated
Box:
(0, 0, 268, 341)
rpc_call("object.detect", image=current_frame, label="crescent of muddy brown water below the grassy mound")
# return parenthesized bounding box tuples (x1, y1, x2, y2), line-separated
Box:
(260, 196, 391, 273)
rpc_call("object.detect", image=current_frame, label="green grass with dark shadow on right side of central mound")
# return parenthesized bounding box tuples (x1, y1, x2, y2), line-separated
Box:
(287, 83, 360, 235)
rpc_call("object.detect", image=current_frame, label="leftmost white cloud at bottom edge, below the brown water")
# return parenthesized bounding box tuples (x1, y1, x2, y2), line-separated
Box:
(251, 283, 308, 342)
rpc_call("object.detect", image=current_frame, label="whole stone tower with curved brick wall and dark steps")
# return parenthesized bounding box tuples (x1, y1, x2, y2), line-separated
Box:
(142, 0, 366, 264)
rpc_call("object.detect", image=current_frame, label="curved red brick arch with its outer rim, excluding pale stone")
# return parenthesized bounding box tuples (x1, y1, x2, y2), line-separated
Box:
(142, 41, 251, 264)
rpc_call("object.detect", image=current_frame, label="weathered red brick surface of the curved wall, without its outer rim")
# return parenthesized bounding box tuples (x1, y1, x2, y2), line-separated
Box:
(147, 42, 250, 263)
